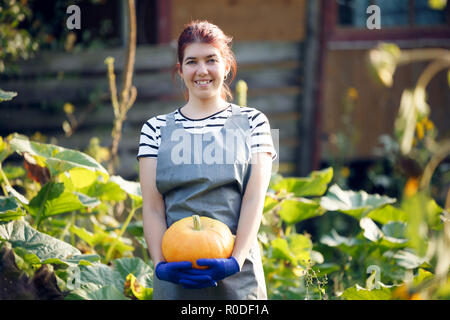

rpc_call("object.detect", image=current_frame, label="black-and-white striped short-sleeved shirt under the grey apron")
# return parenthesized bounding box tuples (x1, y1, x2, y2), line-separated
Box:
(137, 105, 277, 160)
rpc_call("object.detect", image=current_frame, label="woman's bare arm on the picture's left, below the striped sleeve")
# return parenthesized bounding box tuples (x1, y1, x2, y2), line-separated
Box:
(139, 158, 167, 266)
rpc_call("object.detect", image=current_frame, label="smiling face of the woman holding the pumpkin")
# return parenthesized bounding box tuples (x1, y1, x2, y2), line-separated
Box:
(179, 42, 229, 100)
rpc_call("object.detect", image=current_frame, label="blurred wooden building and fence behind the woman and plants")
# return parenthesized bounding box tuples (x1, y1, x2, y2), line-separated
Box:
(0, 0, 450, 203)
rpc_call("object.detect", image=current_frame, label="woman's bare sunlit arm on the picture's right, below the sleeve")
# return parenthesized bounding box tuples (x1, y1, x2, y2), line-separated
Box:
(232, 152, 272, 268)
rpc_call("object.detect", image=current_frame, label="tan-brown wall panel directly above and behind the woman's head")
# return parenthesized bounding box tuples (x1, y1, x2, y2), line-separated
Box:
(171, 0, 306, 41)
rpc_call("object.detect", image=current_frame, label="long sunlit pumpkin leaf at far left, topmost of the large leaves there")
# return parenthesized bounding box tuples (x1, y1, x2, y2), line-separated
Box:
(10, 134, 108, 180)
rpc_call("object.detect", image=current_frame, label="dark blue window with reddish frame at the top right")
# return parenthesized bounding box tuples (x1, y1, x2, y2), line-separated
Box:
(321, 0, 450, 43)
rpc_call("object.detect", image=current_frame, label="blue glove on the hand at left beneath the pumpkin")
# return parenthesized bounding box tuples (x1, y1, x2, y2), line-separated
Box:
(155, 261, 212, 286)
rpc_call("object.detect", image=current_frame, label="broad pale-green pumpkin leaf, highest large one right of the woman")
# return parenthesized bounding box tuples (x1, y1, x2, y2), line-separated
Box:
(320, 184, 396, 219)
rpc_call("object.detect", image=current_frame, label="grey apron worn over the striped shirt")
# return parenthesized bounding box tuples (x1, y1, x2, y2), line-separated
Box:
(153, 104, 267, 300)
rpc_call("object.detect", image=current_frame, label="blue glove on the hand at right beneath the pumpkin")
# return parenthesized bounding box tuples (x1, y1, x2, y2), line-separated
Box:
(193, 257, 240, 281)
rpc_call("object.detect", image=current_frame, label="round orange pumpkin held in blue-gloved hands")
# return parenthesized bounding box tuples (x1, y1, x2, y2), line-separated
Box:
(162, 215, 234, 269)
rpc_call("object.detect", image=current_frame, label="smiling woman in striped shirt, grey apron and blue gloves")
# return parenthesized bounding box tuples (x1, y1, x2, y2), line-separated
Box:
(138, 21, 277, 299)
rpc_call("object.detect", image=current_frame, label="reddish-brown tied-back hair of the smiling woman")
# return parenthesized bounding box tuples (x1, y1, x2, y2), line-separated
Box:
(174, 20, 237, 100)
